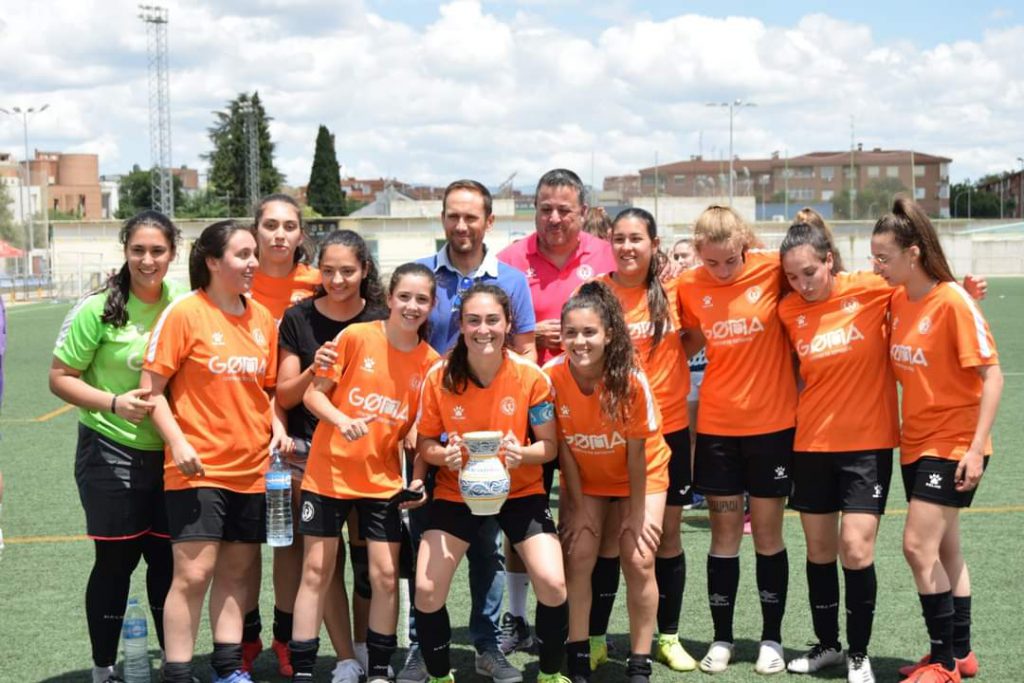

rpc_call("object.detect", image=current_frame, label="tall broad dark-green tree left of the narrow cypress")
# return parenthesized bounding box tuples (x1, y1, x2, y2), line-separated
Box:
(203, 92, 285, 216)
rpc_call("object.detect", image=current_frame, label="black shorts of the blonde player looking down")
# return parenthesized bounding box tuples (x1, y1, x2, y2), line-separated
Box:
(693, 428, 796, 498)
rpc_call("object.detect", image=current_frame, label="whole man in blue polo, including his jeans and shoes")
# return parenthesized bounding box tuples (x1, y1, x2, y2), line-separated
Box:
(396, 180, 537, 683)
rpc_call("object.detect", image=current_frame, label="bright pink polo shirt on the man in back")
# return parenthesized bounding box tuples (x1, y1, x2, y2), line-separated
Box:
(498, 231, 615, 365)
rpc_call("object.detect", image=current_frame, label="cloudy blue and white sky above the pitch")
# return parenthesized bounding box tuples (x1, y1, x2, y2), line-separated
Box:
(0, 0, 1024, 191)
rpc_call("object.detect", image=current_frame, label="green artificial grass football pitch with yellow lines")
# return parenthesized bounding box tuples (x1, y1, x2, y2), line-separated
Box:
(0, 279, 1024, 683)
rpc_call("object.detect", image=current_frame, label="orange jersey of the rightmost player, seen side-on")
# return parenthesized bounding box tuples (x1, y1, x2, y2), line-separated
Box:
(889, 283, 999, 465)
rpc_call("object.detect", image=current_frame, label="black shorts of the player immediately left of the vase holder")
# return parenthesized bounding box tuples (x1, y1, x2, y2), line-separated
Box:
(299, 490, 401, 543)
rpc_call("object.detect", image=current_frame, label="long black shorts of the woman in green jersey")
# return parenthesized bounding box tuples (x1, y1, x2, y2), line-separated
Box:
(75, 423, 168, 541)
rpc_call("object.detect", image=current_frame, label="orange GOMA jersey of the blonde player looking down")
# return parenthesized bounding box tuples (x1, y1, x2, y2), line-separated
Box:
(679, 251, 797, 436)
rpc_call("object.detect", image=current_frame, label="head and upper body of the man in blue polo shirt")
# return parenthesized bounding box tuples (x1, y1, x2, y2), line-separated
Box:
(417, 180, 537, 361)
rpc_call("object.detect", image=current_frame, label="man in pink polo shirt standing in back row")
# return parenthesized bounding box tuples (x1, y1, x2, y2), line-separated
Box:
(498, 168, 615, 365)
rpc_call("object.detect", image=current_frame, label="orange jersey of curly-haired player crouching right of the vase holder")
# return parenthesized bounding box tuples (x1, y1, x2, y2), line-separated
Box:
(544, 355, 672, 498)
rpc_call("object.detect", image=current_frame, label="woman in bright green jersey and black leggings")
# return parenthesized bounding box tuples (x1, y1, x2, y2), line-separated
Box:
(49, 211, 185, 683)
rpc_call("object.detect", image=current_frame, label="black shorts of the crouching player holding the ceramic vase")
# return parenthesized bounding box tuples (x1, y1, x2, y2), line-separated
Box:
(427, 494, 557, 546)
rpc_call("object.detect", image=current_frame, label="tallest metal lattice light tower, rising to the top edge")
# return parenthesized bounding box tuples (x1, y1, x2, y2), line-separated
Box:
(138, 5, 174, 217)
